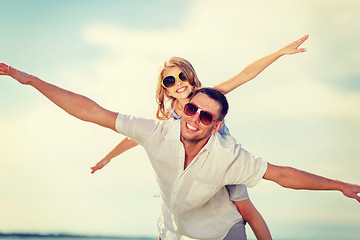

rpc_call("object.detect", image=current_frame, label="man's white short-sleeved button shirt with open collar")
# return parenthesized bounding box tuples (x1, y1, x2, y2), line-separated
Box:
(116, 114, 267, 239)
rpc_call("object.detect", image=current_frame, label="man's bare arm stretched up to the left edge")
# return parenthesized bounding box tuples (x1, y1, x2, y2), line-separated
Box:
(0, 63, 117, 130)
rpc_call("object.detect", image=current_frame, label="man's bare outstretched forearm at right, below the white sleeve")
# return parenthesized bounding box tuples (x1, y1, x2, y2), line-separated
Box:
(263, 163, 360, 202)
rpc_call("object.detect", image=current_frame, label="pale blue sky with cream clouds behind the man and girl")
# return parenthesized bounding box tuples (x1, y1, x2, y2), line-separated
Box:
(0, 0, 360, 239)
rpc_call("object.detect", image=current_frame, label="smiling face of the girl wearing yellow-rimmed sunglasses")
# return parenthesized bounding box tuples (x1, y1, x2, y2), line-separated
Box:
(163, 67, 193, 99)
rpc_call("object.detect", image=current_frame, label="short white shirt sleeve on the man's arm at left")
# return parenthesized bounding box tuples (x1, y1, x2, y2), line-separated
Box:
(115, 113, 159, 145)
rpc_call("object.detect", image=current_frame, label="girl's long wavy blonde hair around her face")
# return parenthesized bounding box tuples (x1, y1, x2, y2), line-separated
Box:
(156, 57, 201, 120)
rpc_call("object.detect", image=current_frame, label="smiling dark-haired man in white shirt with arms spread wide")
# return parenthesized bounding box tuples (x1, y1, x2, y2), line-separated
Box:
(0, 64, 360, 239)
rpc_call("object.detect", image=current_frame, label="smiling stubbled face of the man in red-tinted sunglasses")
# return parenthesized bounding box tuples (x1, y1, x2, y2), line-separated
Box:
(180, 93, 222, 143)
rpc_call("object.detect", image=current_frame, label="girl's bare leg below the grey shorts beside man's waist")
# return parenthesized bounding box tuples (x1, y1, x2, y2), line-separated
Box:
(234, 199, 272, 240)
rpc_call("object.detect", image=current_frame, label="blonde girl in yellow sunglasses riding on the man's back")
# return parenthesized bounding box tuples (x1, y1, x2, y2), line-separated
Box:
(91, 35, 308, 239)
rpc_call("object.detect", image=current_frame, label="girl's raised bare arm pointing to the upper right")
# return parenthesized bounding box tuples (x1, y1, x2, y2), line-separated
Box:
(214, 35, 309, 94)
